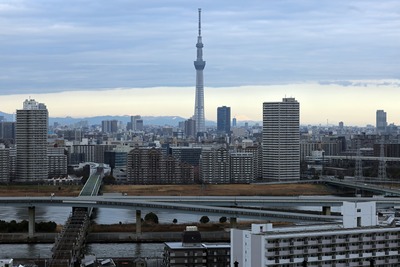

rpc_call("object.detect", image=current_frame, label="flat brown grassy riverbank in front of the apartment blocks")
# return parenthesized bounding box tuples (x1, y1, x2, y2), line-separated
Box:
(0, 183, 337, 197)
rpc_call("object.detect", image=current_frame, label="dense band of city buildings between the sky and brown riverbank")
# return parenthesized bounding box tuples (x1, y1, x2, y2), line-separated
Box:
(0, 98, 400, 184)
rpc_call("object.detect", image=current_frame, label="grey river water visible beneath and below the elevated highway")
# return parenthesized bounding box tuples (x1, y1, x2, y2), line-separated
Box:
(0, 204, 336, 258)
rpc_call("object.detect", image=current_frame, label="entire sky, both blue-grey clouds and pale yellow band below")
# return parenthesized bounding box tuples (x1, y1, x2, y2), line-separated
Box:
(0, 0, 400, 126)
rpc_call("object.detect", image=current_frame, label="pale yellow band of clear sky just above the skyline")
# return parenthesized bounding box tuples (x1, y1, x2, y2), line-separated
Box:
(0, 80, 400, 126)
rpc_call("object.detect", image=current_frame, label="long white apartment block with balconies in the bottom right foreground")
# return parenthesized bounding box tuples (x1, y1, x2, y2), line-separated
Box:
(231, 202, 400, 267)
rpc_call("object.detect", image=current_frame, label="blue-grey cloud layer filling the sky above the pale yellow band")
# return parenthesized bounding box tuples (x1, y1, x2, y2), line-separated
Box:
(0, 0, 400, 123)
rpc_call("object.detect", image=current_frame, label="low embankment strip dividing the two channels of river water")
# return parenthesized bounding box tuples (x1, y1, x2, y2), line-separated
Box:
(0, 231, 230, 244)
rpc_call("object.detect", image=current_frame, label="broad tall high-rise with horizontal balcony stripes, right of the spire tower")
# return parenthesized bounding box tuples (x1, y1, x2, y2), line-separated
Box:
(262, 98, 300, 181)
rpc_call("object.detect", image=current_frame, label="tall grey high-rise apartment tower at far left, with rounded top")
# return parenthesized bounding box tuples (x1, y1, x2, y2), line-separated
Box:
(15, 99, 48, 182)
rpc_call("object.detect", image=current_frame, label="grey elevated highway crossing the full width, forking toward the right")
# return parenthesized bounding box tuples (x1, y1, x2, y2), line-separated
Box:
(0, 196, 400, 228)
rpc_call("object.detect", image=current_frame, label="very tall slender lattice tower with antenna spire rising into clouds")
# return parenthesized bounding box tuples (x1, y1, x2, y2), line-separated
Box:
(194, 8, 206, 133)
